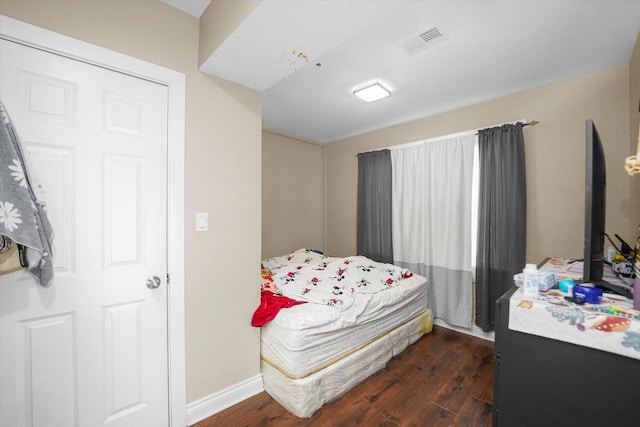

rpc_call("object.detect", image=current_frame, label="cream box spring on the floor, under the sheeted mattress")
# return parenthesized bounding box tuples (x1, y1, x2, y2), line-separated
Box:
(261, 309, 433, 418)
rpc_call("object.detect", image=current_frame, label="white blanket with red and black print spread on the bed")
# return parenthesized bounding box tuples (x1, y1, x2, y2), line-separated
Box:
(263, 249, 413, 310)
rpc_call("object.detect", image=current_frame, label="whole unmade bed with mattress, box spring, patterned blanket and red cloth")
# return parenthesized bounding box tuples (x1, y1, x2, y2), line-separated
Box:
(254, 249, 433, 418)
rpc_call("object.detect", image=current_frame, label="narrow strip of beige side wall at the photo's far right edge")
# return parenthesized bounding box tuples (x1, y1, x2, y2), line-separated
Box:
(628, 34, 640, 243)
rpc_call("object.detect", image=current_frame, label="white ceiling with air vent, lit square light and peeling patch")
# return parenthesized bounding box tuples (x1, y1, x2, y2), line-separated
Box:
(163, 0, 640, 142)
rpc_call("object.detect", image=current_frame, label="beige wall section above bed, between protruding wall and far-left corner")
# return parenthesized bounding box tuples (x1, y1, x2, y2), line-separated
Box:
(262, 131, 324, 258)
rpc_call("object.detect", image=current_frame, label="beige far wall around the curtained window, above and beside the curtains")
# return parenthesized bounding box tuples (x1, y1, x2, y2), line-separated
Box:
(325, 65, 631, 262)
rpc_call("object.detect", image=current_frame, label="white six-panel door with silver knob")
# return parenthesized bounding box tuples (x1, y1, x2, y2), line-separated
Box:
(0, 40, 169, 427)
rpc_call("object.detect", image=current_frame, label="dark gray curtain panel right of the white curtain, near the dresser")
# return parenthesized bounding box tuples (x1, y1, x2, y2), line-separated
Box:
(476, 123, 527, 331)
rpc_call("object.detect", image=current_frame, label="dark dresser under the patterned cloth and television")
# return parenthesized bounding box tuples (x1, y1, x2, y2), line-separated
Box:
(493, 287, 640, 427)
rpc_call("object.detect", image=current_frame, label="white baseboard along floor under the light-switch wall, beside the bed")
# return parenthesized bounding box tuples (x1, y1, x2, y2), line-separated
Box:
(187, 374, 264, 426)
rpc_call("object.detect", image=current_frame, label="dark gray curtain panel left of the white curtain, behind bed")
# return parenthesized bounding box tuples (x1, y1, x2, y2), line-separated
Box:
(357, 150, 393, 263)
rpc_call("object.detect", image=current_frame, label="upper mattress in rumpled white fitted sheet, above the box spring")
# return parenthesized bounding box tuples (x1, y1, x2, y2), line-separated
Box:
(261, 275, 428, 378)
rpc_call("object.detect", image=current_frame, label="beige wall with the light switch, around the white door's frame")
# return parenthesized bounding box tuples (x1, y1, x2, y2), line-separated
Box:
(0, 0, 262, 402)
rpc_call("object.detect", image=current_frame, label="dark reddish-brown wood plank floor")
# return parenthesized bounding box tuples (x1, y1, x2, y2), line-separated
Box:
(195, 327, 493, 427)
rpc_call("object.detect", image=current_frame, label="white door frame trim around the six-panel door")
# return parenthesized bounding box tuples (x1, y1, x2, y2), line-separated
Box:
(0, 15, 187, 426)
